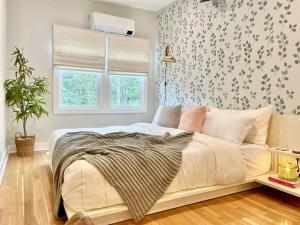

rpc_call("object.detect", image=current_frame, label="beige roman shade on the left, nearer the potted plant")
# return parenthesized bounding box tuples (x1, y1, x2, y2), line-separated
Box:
(53, 25, 105, 70)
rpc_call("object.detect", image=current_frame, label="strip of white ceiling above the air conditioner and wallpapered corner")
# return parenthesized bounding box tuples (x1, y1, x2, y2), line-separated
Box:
(95, 0, 174, 12)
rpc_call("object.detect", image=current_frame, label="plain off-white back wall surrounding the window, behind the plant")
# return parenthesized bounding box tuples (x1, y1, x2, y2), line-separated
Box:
(8, 0, 158, 143)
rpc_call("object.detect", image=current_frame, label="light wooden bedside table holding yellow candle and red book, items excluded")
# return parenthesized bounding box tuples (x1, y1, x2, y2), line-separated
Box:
(255, 148, 300, 198)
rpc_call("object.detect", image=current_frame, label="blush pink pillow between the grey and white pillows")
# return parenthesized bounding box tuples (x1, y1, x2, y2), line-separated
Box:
(178, 106, 207, 133)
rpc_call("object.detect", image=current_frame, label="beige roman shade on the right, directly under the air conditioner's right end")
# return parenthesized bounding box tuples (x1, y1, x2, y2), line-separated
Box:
(108, 35, 150, 75)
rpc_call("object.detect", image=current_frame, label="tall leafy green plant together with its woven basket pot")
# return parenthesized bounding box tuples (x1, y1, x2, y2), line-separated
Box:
(4, 48, 48, 156)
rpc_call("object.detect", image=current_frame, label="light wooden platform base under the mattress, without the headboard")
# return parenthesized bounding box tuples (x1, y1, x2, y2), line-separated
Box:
(87, 179, 262, 225)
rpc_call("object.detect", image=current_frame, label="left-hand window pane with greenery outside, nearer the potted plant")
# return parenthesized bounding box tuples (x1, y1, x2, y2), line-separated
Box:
(58, 69, 100, 109)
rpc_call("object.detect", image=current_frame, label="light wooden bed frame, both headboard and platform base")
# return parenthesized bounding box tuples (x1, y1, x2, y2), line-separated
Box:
(65, 115, 300, 225)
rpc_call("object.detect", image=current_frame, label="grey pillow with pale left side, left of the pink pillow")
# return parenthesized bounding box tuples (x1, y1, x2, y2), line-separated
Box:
(152, 105, 181, 128)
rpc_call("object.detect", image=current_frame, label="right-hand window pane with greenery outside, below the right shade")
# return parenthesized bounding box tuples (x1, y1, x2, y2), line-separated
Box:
(110, 75, 146, 109)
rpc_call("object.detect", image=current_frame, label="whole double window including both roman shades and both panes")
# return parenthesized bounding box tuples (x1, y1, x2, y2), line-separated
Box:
(52, 25, 150, 114)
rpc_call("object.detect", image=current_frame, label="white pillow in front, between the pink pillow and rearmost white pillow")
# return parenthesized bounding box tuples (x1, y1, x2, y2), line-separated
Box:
(202, 111, 255, 144)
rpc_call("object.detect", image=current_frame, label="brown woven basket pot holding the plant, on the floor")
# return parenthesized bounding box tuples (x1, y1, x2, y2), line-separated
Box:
(15, 133, 35, 157)
